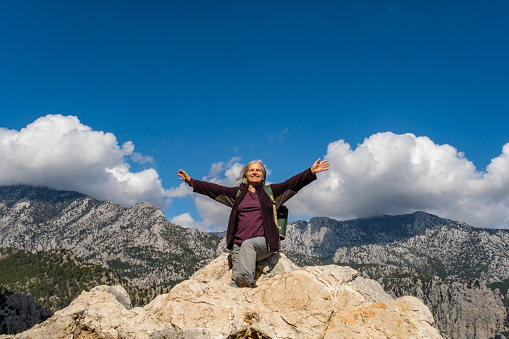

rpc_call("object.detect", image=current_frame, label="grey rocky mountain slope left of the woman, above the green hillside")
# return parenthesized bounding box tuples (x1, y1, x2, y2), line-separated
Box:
(0, 185, 222, 287)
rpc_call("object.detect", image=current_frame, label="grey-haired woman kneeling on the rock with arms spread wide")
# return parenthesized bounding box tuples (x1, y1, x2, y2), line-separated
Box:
(178, 159, 329, 287)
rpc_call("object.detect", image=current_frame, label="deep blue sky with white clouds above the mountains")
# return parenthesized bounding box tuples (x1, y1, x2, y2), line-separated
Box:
(0, 0, 509, 231)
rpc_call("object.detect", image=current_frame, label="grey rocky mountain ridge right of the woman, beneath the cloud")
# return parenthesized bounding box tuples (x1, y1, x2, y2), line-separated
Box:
(283, 212, 509, 284)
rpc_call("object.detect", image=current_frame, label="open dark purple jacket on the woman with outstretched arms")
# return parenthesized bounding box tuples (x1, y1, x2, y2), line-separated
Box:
(193, 168, 316, 252)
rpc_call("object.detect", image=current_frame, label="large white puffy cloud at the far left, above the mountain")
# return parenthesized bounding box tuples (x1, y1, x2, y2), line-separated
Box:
(0, 115, 168, 207)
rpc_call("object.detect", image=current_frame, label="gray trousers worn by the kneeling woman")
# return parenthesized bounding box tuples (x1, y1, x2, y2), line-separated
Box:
(230, 237, 272, 286)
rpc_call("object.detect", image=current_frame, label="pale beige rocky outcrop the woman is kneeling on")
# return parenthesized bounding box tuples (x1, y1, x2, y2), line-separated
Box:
(0, 254, 441, 339)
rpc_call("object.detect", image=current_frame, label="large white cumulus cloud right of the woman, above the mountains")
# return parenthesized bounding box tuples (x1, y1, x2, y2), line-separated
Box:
(288, 133, 509, 227)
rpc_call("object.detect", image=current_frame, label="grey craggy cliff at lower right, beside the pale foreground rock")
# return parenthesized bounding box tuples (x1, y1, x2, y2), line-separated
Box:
(356, 265, 507, 339)
